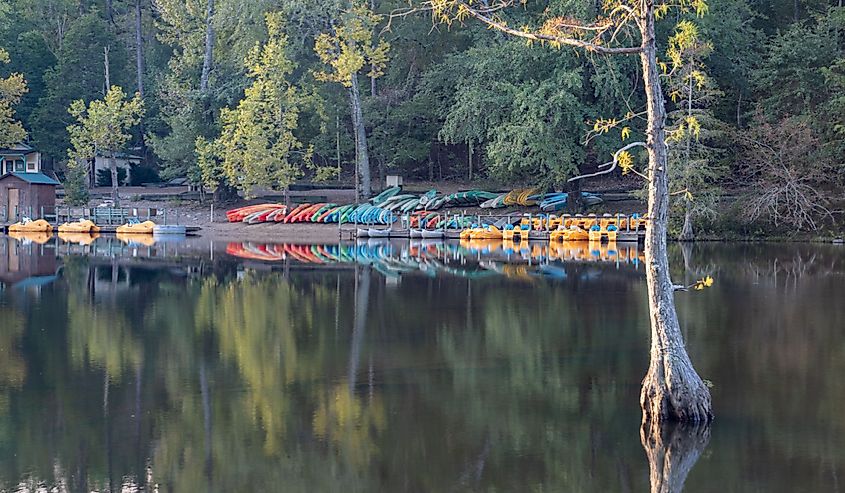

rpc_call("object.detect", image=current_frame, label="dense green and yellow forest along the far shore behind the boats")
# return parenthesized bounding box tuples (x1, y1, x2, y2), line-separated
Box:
(0, 0, 845, 229)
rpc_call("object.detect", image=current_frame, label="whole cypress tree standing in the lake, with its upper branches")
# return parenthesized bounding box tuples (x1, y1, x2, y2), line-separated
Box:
(426, 0, 713, 422)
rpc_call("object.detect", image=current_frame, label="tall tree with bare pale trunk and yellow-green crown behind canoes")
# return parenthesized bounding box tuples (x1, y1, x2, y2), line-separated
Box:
(314, 3, 390, 198)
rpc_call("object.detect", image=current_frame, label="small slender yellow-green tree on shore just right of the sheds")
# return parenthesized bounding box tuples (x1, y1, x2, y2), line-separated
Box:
(67, 86, 144, 207)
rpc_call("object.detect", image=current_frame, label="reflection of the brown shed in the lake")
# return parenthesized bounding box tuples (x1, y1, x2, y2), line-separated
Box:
(0, 237, 56, 288)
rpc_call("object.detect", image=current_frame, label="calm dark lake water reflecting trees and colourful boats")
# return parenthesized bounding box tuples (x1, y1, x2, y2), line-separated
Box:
(0, 237, 845, 492)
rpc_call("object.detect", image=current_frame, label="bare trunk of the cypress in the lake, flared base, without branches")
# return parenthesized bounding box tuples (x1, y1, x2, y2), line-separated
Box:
(639, 0, 713, 424)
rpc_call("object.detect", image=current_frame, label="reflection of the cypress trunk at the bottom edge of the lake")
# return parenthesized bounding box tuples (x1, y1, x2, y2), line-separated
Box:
(640, 423, 710, 493)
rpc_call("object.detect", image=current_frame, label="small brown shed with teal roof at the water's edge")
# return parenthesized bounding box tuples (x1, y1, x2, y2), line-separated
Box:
(0, 173, 59, 222)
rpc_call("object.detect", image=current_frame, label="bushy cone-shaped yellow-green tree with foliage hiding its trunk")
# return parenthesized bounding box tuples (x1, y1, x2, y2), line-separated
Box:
(197, 13, 322, 196)
